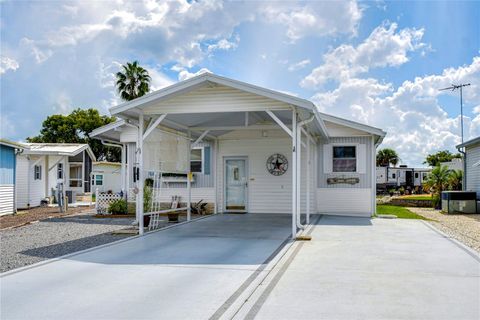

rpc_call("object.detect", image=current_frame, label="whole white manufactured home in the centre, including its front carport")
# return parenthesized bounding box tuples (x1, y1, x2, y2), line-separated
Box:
(91, 73, 385, 235)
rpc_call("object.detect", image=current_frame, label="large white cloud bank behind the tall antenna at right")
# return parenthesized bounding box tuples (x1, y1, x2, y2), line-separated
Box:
(312, 56, 480, 166)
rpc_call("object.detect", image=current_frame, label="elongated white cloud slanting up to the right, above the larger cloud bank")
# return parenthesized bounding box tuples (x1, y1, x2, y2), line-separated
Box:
(301, 23, 425, 88)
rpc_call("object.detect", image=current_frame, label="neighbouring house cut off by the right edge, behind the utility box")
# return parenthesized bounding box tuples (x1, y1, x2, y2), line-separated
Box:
(457, 137, 480, 199)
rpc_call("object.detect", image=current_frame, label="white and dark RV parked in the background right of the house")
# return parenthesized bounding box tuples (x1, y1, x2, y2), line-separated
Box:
(376, 165, 431, 193)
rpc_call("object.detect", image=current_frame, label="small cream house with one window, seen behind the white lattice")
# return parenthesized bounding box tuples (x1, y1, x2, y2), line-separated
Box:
(90, 161, 122, 193)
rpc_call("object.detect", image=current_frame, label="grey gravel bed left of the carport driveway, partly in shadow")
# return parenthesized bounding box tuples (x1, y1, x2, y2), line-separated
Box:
(0, 212, 133, 272)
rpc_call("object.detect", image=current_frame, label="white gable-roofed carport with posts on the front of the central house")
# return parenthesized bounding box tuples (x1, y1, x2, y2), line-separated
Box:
(92, 73, 328, 238)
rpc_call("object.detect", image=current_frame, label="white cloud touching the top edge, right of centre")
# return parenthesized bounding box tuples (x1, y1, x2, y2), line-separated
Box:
(260, 1, 362, 41)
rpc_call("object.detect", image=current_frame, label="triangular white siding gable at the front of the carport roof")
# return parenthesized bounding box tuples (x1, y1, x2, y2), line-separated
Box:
(144, 85, 290, 114)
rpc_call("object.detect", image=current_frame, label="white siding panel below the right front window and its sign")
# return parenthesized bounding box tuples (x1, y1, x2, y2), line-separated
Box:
(317, 188, 373, 217)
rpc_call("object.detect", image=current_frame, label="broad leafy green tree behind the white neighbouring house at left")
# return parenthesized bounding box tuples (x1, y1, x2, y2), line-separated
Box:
(27, 109, 120, 162)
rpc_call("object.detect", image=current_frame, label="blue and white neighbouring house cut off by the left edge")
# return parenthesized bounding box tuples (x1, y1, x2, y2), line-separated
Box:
(0, 139, 25, 216)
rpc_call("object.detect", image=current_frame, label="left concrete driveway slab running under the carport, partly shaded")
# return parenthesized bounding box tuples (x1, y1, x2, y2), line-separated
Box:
(0, 214, 291, 319)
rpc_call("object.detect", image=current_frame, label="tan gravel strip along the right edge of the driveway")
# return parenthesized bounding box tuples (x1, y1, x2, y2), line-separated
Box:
(408, 208, 480, 252)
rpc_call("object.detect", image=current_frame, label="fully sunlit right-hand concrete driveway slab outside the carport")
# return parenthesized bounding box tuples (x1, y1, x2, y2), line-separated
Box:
(240, 216, 480, 320)
